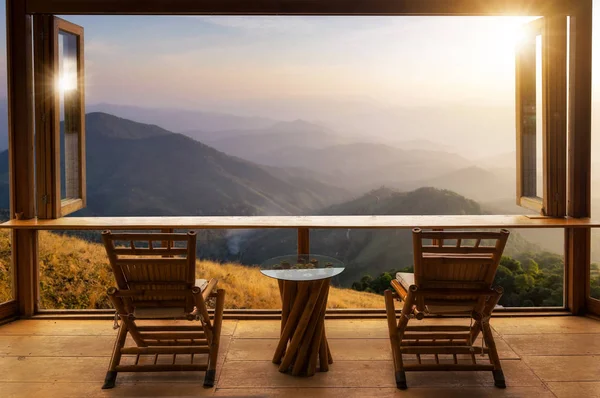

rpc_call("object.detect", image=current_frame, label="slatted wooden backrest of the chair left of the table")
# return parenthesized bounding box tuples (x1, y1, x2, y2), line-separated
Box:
(102, 231, 196, 311)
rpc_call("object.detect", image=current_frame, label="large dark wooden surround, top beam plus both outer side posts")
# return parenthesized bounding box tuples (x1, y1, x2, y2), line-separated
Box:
(6, 0, 600, 316)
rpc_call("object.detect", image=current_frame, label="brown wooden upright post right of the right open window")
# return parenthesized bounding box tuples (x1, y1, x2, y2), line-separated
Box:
(565, 0, 599, 314)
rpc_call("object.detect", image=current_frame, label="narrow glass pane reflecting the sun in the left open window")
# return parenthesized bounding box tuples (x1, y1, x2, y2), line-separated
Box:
(58, 32, 81, 199)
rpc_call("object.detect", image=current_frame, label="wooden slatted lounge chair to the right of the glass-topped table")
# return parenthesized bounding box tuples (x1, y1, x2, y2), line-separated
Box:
(385, 228, 509, 389)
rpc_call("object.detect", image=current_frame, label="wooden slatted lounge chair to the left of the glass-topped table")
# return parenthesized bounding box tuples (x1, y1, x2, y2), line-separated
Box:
(102, 231, 225, 389)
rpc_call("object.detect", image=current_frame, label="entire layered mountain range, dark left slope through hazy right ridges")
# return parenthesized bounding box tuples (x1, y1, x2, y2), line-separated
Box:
(0, 112, 552, 286)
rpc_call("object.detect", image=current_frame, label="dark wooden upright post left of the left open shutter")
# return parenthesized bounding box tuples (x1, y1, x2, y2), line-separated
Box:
(6, 0, 38, 316)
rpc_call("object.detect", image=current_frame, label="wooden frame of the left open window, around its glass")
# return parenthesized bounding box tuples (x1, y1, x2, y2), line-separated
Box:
(34, 15, 87, 219)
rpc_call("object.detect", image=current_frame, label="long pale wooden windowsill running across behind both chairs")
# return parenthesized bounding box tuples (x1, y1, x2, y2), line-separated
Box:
(0, 215, 600, 230)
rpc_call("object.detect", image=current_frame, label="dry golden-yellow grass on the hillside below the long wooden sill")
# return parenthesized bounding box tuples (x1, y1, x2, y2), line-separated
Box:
(0, 231, 383, 309)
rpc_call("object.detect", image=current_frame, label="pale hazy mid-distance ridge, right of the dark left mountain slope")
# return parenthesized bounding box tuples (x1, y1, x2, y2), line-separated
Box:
(210, 137, 471, 194)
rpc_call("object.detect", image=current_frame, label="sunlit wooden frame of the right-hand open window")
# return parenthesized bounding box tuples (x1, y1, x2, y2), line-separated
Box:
(515, 16, 567, 217)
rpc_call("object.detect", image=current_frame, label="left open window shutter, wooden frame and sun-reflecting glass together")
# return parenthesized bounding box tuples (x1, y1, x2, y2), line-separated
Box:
(34, 15, 86, 219)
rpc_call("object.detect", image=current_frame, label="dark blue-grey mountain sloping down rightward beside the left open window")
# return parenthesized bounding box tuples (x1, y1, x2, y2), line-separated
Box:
(0, 113, 348, 216)
